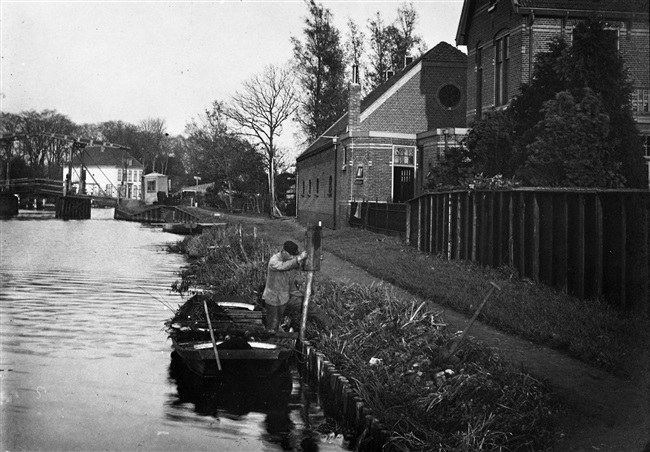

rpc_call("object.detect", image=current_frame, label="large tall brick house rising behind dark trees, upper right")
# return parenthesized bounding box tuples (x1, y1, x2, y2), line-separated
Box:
(456, 0, 650, 179)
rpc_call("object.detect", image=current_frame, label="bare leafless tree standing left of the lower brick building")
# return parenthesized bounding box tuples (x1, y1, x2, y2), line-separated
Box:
(224, 65, 298, 217)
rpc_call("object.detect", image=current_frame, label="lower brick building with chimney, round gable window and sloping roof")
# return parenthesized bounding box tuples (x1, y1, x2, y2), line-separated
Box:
(296, 42, 467, 229)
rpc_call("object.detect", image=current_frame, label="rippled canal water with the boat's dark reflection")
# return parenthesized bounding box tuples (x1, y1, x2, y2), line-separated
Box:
(0, 209, 348, 451)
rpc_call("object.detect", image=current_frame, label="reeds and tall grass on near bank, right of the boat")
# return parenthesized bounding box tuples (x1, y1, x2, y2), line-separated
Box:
(308, 281, 558, 451)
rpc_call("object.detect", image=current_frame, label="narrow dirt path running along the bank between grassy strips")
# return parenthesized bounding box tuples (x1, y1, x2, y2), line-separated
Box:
(215, 214, 650, 452)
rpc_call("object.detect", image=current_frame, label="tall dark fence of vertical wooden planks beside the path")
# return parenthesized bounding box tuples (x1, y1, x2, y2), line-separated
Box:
(404, 189, 650, 308)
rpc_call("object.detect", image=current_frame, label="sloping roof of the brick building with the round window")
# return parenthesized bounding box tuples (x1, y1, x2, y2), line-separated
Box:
(297, 41, 467, 160)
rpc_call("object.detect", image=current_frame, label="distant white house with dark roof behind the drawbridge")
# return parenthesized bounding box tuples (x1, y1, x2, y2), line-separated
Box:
(63, 146, 144, 199)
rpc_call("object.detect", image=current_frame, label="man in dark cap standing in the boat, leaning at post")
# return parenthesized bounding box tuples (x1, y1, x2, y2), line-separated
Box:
(262, 241, 332, 331)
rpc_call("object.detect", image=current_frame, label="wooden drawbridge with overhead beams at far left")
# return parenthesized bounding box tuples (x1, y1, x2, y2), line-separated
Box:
(0, 132, 130, 219)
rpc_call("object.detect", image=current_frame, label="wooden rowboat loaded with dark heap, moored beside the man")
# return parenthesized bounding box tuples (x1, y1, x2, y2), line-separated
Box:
(166, 294, 298, 377)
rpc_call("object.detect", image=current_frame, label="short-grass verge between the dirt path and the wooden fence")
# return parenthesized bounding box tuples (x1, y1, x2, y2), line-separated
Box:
(173, 212, 648, 377)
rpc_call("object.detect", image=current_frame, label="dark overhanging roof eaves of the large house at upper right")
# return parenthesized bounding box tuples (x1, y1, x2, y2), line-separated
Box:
(456, 0, 648, 46)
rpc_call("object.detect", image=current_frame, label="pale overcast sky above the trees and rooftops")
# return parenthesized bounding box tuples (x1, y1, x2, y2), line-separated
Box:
(0, 0, 466, 152)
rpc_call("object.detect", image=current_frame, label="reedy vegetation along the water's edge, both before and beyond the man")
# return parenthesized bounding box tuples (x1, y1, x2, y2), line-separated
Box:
(172, 224, 559, 451)
